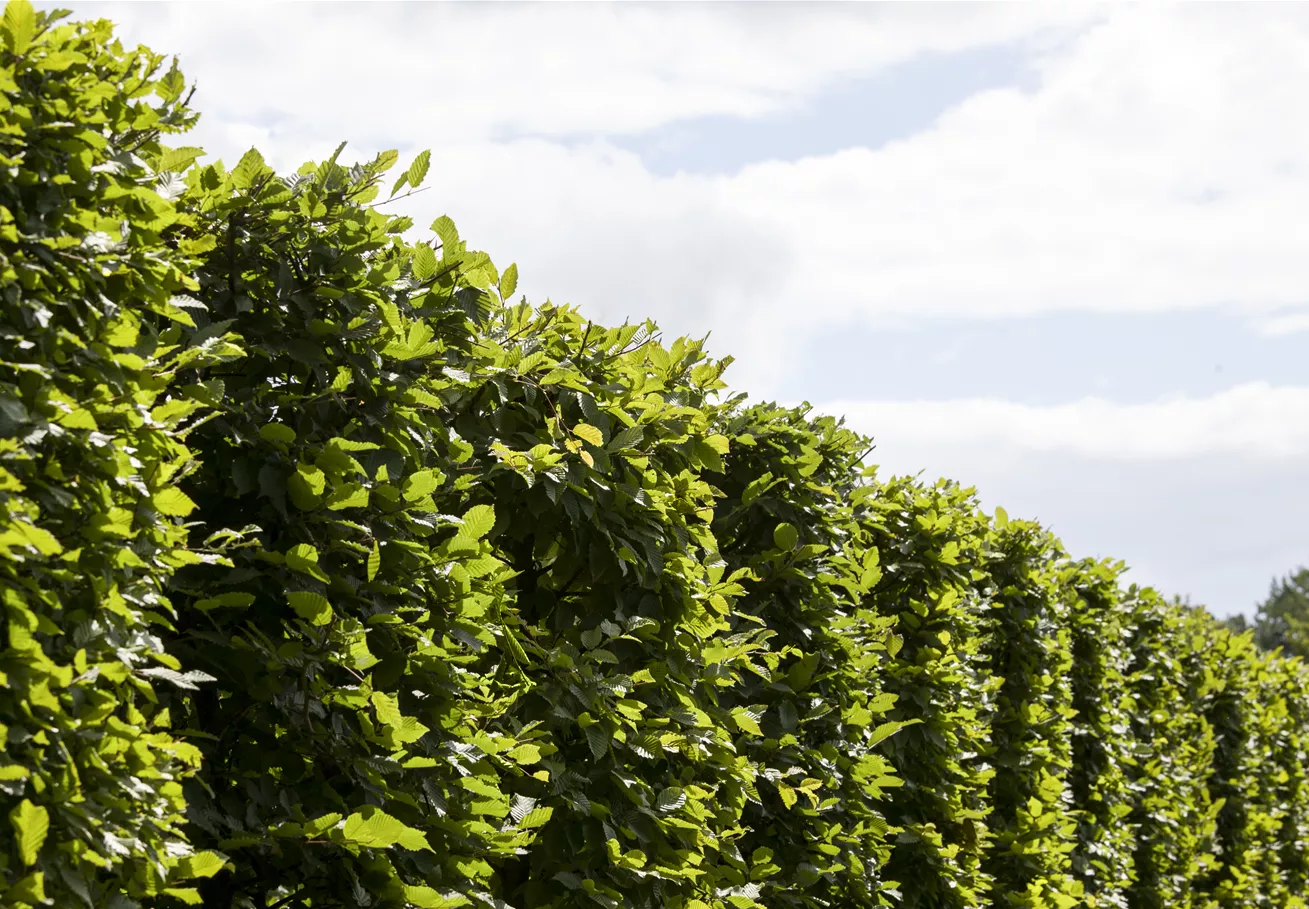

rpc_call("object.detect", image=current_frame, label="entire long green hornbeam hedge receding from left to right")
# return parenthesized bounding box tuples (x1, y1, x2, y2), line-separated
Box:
(0, 3, 1309, 909)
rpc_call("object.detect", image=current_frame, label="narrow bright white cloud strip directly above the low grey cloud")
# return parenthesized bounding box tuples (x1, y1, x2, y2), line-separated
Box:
(821, 382, 1309, 461)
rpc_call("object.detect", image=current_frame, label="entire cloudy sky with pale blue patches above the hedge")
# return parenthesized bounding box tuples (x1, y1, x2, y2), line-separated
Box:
(60, 3, 1309, 614)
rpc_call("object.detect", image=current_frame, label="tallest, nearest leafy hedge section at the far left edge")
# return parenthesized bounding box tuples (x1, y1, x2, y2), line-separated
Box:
(0, 4, 240, 906)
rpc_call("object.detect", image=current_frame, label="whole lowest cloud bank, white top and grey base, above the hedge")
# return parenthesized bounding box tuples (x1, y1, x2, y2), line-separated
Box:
(816, 384, 1309, 616)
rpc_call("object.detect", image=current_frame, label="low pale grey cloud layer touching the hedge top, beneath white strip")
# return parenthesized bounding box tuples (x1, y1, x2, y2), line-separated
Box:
(837, 440, 1309, 616)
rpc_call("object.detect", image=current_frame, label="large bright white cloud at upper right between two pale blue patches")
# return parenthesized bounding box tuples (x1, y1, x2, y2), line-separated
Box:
(725, 7, 1309, 320)
